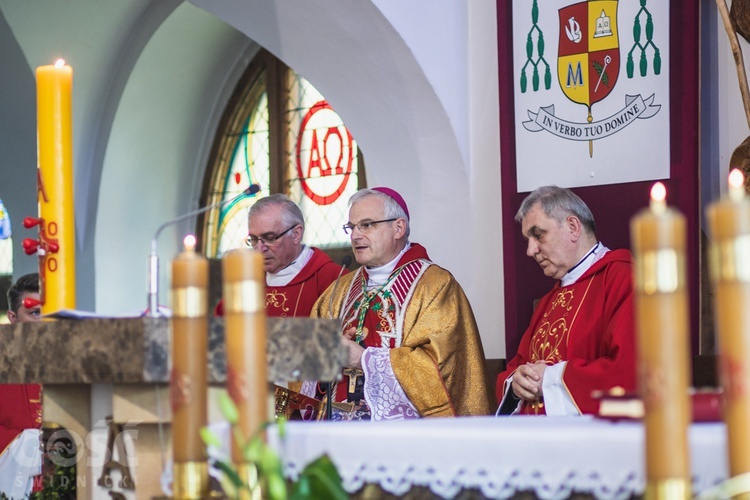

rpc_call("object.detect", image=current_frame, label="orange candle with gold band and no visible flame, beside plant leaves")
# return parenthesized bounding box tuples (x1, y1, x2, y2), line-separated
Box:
(222, 249, 273, 464)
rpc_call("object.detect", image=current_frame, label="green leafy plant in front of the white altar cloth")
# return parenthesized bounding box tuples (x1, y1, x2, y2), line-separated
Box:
(201, 393, 349, 500)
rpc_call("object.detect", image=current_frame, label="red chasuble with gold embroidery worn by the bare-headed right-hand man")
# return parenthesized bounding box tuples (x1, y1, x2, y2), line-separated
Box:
(496, 250, 636, 415)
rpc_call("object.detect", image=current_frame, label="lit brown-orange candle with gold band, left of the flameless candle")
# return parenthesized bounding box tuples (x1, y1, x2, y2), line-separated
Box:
(170, 235, 208, 499)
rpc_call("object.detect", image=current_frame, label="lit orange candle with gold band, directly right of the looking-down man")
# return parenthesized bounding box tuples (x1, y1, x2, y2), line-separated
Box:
(630, 182, 691, 499)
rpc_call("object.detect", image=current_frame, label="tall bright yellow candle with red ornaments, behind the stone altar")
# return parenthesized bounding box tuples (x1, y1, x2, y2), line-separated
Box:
(36, 59, 76, 314)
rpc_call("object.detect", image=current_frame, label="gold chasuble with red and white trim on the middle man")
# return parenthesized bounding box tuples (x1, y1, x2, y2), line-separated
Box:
(311, 243, 490, 417)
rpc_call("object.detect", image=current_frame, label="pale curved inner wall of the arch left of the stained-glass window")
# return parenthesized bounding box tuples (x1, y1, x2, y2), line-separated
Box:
(96, 3, 249, 314)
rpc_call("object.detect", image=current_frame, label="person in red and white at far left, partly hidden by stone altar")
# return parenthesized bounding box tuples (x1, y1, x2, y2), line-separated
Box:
(0, 273, 42, 498)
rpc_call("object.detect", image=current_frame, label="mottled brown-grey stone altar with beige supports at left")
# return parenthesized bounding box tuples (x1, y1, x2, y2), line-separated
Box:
(0, 317, 347, 499)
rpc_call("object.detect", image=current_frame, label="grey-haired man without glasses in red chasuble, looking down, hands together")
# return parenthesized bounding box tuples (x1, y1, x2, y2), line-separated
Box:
(496, 186, 636, 415)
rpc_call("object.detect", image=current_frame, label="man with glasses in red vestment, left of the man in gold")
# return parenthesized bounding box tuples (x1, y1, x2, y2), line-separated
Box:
(216, 194, 341, 317)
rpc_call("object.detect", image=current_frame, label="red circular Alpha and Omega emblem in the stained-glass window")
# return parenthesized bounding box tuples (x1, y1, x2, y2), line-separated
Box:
(296, 101, 354, 205)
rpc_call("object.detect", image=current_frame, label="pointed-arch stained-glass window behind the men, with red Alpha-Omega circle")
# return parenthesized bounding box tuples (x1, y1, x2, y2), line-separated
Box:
(199, 51, 364, 258)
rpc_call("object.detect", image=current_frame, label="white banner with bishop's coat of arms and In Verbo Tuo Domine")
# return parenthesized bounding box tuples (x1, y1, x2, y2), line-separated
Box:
(513, 0, 670, 192)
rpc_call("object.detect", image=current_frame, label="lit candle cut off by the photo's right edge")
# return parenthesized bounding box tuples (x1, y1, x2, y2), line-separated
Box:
(707, 169, 750, 482)
